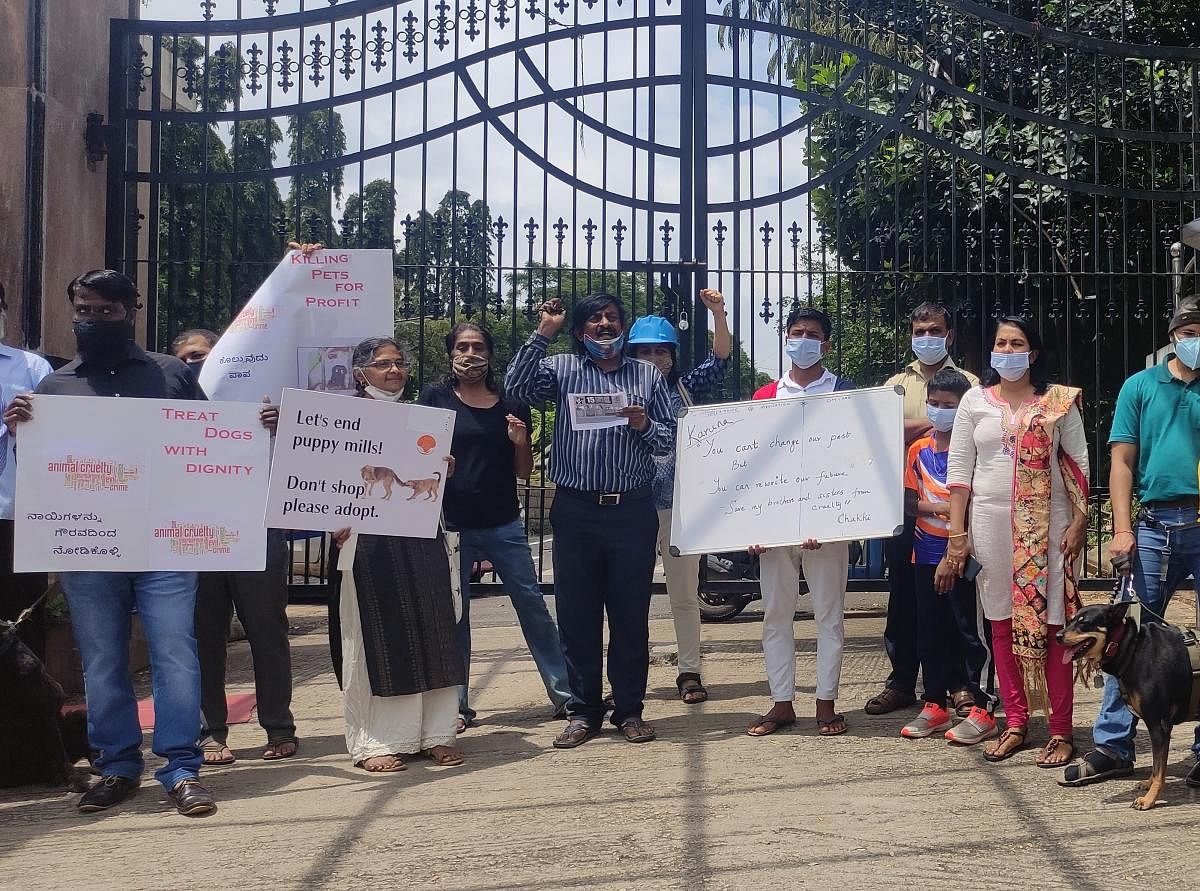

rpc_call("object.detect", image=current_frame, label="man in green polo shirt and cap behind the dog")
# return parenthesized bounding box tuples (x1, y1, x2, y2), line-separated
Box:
(1058, 298, 1200, 787)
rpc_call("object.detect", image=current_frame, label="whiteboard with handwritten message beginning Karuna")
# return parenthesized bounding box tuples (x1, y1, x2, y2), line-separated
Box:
(671, 387, 904, 554)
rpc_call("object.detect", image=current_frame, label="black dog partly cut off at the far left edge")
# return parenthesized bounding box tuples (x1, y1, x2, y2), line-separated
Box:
(0, 622, 89, 793)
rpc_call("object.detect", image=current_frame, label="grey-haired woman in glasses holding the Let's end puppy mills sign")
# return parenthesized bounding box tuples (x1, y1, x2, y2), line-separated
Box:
(330, 337, 466, 773)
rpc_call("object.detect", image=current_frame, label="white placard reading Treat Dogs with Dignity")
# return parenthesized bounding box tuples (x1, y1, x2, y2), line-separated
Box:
(14, 396, 271, 573)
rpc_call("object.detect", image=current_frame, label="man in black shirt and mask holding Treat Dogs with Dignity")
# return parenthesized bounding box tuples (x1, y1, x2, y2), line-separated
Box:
(4, 269, 218, 817)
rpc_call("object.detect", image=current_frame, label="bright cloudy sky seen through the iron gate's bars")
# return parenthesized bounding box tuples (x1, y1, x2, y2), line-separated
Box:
(142, 0, 835, 372)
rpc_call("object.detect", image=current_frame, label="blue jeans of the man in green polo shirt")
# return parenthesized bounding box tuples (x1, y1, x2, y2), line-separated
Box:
(1092, 508, 1200, 761)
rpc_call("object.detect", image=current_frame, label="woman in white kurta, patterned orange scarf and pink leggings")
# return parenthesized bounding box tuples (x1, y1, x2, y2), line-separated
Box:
(937, 316, 1088, 767)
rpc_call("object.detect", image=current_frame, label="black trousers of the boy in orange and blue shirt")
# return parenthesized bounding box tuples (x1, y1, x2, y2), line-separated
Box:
(916, 566, 997, 712)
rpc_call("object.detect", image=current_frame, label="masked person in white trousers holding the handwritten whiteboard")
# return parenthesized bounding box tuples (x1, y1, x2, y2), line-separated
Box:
(746, 306, 854, 736)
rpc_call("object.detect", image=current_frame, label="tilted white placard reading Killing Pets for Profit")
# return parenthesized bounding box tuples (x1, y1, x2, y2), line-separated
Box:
(200, 250, 396, 402)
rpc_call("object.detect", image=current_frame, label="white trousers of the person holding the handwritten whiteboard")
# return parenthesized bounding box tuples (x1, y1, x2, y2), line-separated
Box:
(758, 542, 850, 702)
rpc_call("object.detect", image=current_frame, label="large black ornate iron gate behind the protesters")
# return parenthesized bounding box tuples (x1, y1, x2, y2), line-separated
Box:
(107, 0, 1200, 595)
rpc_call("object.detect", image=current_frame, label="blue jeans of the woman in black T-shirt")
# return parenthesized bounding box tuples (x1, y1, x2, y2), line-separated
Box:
(458, 520, 571, 719)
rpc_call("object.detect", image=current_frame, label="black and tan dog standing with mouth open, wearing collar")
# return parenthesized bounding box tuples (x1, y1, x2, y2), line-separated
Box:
(1058, 603, 1198, 811)
